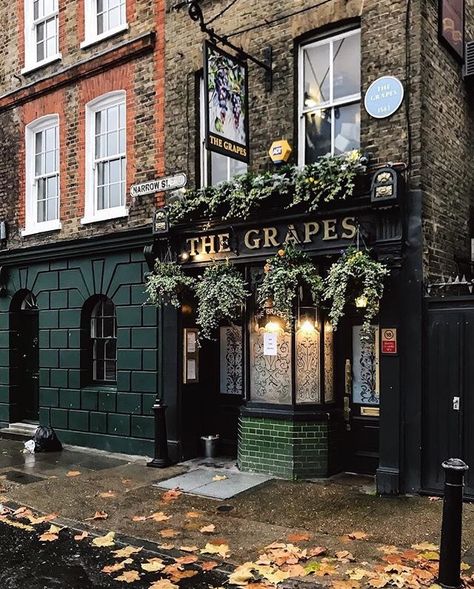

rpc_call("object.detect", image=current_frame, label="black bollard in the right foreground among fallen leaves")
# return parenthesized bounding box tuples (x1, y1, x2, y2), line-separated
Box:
(438, 458, 469, 589)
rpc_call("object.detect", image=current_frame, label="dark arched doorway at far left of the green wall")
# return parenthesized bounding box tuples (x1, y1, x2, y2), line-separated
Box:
(10, 290, 39, 422)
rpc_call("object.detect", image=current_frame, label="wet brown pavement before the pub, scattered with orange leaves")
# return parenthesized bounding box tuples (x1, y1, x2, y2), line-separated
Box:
(0, 439, 474, 589)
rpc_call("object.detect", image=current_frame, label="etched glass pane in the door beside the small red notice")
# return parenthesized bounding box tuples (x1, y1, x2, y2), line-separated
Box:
(352, 325, 380, 405)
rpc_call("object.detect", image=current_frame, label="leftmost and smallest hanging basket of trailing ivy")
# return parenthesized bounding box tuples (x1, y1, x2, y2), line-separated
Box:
(145, 260, 196, 308)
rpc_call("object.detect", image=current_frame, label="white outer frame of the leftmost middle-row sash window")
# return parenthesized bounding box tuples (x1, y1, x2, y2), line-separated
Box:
(21, 114, 61, 236)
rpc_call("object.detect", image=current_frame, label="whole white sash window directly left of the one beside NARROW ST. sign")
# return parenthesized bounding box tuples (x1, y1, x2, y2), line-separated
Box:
(23, 115, 61, 235)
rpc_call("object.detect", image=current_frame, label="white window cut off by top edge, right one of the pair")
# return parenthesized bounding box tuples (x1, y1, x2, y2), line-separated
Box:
(81, 0, 128, 47)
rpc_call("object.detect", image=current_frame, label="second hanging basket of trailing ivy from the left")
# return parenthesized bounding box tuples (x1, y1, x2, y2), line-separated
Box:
(196, 261, 250, 339)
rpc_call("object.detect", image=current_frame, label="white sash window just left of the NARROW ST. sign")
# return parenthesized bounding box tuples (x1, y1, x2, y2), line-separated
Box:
(82, 91, 128, 223)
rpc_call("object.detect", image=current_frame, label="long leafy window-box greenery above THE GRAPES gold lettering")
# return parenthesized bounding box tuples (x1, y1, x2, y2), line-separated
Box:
(169, 151, 362, 224)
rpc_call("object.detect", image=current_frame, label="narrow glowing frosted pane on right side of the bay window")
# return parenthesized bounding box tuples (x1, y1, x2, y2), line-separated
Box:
(296, 329, 321, 403)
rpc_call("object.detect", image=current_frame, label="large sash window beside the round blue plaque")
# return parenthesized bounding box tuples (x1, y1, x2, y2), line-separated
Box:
(298, 30, 361, 165)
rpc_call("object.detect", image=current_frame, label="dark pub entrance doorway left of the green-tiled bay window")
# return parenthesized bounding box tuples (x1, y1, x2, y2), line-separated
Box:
(181, 305, 243, 459)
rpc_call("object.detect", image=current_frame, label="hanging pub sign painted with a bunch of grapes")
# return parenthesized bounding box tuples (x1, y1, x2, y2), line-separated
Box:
(204, 41, 249, 163)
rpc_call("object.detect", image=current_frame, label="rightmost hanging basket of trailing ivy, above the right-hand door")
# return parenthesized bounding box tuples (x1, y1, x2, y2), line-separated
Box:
(324, 247, 389, 339)
